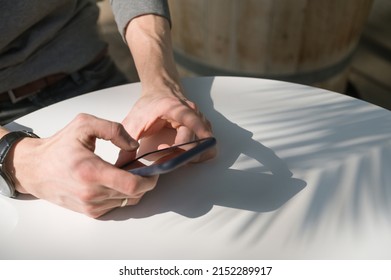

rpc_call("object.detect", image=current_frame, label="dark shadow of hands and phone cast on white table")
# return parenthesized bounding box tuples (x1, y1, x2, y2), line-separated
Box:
(105, 78, 306, 220)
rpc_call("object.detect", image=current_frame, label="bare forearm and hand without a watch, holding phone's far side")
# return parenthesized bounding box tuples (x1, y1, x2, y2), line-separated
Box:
(119, 15, 216, 164)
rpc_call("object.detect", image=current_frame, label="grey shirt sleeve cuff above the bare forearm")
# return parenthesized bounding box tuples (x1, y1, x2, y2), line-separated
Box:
(110, 0, 171, 38)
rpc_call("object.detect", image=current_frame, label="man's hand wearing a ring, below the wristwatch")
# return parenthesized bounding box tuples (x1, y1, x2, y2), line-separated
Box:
(5, 114, 158, 218)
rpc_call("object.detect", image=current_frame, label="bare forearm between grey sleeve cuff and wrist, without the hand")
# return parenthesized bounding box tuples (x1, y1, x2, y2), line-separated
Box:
(125, 15, 181, 94)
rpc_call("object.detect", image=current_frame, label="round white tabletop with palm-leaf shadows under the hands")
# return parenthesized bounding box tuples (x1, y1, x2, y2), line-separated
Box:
(0, 77, 391, 259)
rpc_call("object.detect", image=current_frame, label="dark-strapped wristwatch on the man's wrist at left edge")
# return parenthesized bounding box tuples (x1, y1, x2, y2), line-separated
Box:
(0, 131, 39, 197)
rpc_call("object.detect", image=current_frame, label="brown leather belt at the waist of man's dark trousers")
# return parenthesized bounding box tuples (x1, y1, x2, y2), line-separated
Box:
(0, 48, 107, 103)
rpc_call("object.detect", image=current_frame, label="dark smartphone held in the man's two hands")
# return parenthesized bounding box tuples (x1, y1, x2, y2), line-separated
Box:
(121, 137, 216, 176)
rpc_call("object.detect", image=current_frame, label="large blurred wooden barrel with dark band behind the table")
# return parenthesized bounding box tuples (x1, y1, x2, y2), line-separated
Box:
(169, 0, 373, 92)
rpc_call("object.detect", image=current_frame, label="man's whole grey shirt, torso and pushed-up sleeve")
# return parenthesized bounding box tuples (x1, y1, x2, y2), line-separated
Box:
(0, 0, 169, 93)
